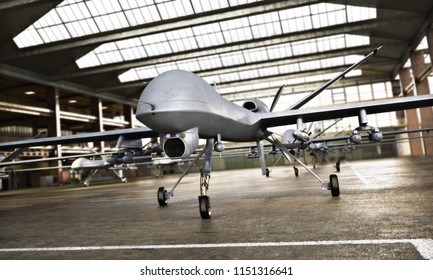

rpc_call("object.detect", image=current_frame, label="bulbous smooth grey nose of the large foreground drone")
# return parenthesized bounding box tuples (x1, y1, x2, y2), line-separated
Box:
(136, 70, 224, 133)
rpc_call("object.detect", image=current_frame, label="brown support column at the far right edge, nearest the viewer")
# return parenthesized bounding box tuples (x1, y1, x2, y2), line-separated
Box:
(410, 51, 433, 155)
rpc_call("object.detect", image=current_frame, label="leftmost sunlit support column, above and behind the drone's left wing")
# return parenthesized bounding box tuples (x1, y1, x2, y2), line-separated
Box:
(47, 87, 62, 183)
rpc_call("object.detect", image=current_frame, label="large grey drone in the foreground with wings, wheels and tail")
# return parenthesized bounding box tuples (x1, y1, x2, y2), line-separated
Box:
(0, 49, 433, 219)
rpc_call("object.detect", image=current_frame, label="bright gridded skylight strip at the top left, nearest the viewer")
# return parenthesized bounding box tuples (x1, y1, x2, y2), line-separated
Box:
(14, 0, 237, 48)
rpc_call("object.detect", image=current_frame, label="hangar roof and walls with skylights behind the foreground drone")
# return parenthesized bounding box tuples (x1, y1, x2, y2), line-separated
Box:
(0, 0, 433, 189)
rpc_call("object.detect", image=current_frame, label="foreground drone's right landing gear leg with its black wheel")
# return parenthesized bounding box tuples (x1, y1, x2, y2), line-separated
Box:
(266, 137, 340, 197)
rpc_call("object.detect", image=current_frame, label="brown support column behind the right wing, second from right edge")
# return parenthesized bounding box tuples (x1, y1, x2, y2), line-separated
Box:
(399, 69, 424, 156)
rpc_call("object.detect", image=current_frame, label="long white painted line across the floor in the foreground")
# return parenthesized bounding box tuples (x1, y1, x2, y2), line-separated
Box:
(0, 239, 433, 260)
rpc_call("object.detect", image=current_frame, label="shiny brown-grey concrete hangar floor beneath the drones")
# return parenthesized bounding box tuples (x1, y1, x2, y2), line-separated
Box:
(0, 157, 433, 259)
